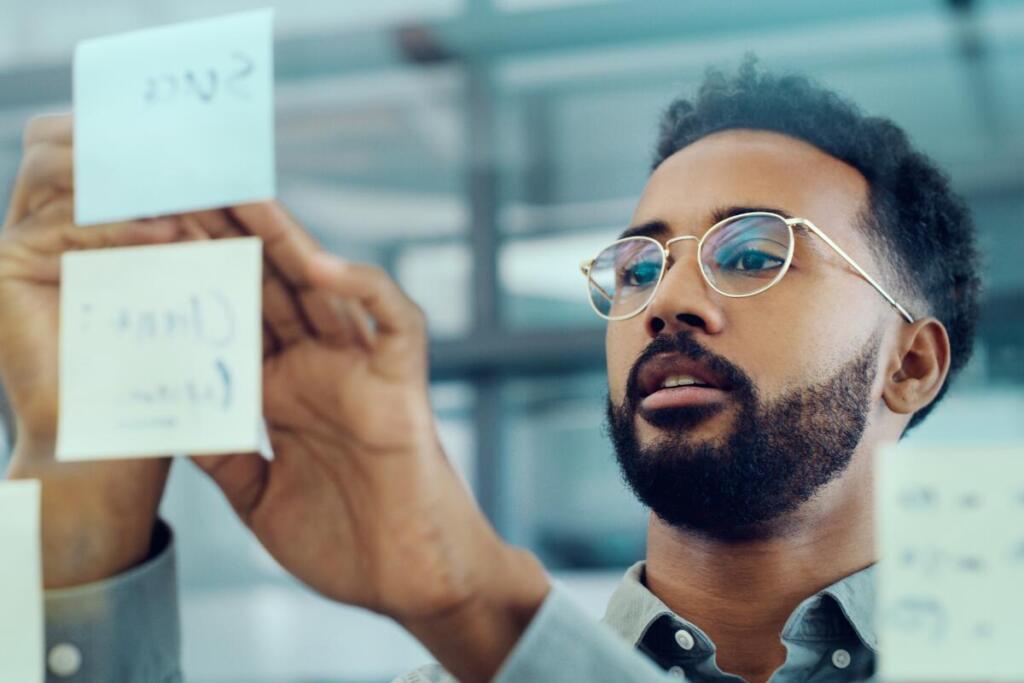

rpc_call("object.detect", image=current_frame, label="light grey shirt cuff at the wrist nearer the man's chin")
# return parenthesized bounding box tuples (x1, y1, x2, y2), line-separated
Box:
(493, 585, 685, 683)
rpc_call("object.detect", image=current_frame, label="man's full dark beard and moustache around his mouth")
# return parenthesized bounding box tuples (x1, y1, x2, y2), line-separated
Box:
(607, 332, 881, 541)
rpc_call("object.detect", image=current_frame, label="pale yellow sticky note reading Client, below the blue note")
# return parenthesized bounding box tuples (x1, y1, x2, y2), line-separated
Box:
(57, 238, 262, 461)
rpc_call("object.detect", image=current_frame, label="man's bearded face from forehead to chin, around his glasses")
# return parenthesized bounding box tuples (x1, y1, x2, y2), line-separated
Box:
(606, 130, 893, 538)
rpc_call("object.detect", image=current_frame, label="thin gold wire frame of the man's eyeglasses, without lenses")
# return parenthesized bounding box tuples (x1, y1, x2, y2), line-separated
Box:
(580, 211, 914, 324)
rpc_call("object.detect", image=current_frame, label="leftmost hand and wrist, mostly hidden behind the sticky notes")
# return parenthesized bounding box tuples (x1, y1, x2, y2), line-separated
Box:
(0, 116, 182, 588)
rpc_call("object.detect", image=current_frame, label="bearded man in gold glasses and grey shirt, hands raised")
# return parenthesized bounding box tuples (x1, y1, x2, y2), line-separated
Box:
(0, 61, 978, 683)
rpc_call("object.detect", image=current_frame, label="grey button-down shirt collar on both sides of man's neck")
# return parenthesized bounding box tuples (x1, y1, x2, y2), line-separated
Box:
(602, 562, 878, 652)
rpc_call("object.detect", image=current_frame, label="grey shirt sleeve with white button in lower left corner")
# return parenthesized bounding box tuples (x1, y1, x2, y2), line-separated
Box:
(45, 522, 181, 683)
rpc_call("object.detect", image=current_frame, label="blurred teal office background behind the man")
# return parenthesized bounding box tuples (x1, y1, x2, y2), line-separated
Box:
(0, 0, 1024, 683)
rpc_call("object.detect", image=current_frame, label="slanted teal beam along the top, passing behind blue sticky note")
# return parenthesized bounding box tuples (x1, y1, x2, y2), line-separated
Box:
(0, 0, 999, 108)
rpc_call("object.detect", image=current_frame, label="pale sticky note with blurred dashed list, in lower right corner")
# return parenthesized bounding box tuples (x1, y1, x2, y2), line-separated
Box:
(876, 444, 1024, 682)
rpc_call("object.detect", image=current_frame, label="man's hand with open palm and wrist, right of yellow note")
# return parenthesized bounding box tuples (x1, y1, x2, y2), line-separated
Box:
(191, 204, 548, 681)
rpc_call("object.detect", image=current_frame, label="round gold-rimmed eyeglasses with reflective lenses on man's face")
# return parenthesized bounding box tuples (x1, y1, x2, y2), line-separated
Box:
(580, 211, 914, 323)
